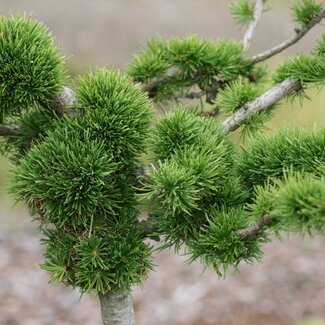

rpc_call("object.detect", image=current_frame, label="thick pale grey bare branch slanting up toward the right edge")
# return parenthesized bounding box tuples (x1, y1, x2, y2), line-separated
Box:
(222, 79, 301, 132)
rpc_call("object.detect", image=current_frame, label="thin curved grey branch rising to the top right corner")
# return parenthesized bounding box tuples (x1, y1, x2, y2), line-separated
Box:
(253, 7, 325, 63)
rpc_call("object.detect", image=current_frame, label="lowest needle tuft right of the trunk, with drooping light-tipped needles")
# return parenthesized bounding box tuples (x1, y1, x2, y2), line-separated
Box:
(189, 207, 267, 276)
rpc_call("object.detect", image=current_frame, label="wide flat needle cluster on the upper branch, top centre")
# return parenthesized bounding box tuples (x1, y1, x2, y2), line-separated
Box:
(128, 36, 252, 101)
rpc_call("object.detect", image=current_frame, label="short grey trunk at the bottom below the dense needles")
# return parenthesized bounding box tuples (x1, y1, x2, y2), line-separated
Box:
(99, 292, 135, 325)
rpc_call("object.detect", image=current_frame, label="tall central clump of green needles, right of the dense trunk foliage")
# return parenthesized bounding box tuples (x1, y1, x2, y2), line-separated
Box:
(143, 107, 246, 249)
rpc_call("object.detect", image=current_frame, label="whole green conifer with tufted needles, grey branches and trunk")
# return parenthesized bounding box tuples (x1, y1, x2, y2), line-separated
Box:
(0, 0, 325, 325)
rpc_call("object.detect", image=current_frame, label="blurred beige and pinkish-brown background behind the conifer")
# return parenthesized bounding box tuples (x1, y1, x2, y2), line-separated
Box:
(0, 0, 325, 325)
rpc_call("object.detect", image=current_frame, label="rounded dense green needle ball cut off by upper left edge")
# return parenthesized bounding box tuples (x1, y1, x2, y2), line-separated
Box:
(0, 16, 65, 122)
